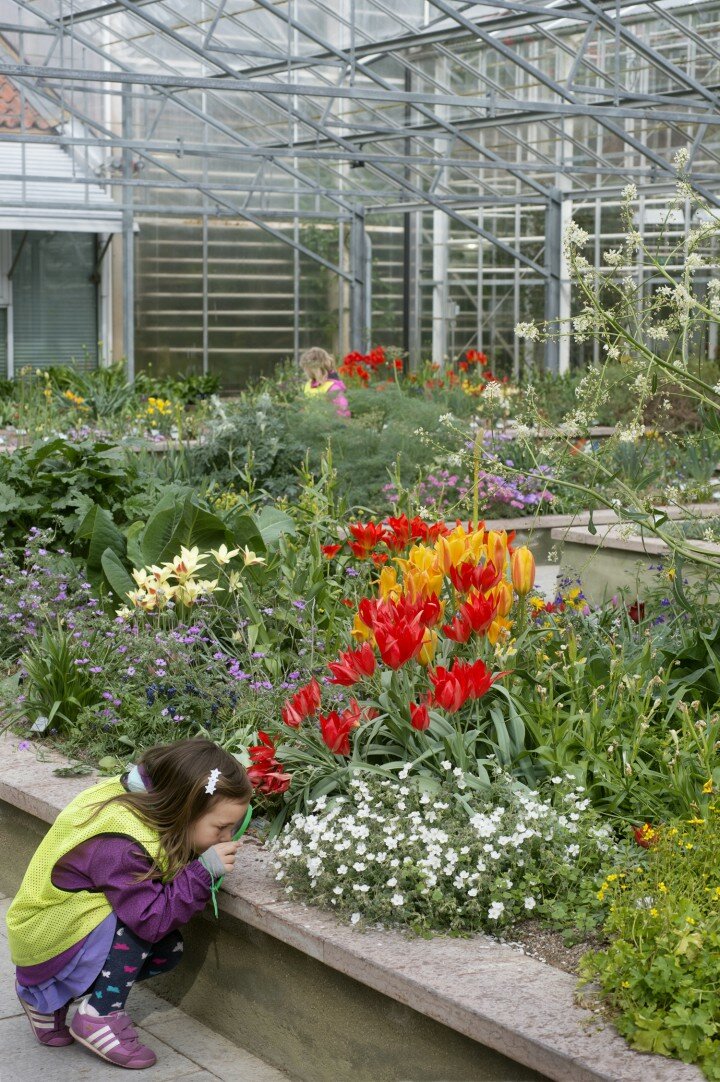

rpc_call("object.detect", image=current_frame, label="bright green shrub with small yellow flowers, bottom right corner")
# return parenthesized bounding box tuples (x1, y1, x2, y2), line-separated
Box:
(582, 813, 720, 1080)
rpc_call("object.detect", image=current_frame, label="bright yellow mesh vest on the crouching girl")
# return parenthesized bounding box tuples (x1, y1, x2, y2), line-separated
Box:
(6, 778, 163, 965)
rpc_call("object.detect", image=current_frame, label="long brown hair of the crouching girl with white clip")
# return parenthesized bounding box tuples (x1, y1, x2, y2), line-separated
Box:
(92, 737, 252, 880)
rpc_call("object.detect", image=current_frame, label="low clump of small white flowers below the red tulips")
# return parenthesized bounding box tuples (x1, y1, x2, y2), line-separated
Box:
(266, 770, 624, 932)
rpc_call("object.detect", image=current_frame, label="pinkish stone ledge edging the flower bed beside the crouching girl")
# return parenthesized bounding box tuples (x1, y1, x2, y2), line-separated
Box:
(0, 734, 703, 1082)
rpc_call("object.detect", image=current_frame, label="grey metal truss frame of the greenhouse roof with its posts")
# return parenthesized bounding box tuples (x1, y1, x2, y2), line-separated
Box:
(0, 0, 720, 367)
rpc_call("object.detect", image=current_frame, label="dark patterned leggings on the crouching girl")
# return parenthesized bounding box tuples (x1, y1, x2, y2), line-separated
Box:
(87, 924, 183, 1015)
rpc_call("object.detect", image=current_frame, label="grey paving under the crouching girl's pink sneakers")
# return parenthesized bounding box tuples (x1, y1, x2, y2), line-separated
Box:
(0, 895, 288, 1082)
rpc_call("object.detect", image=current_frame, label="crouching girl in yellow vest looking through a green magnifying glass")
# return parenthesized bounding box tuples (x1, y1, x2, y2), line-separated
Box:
(6, 738, 252, 1070)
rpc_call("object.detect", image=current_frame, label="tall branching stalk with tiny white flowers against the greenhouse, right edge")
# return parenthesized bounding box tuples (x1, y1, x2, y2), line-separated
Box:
(515, 151, 720, 568)
